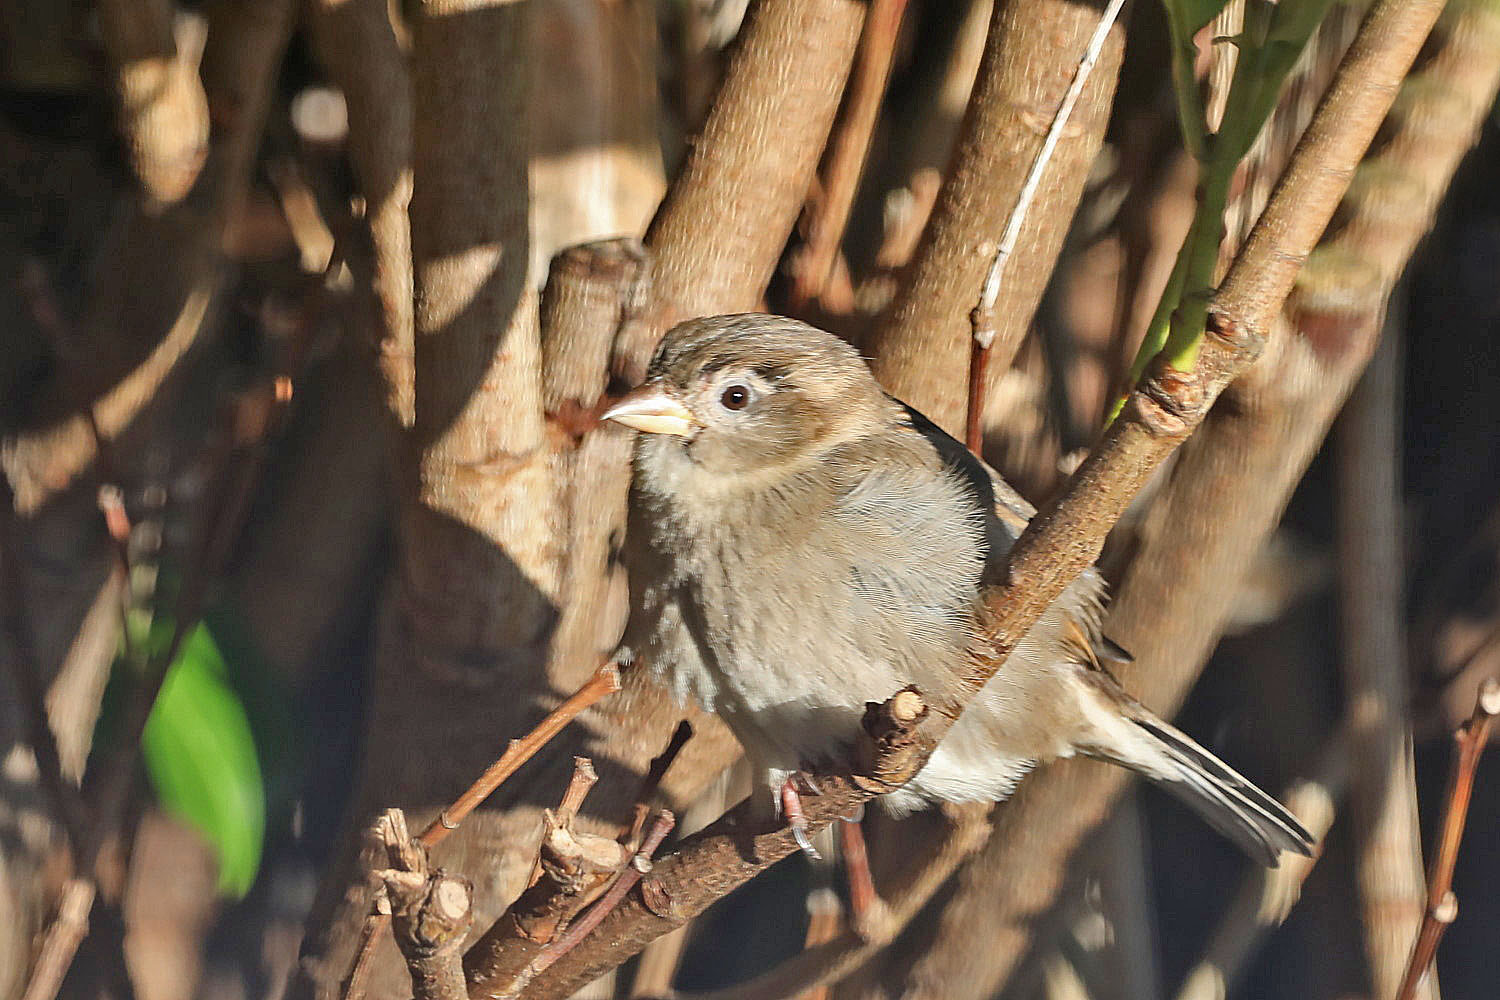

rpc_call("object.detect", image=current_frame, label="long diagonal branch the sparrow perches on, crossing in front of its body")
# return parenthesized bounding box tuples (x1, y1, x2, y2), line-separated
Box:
(510, 0, 1440, 999)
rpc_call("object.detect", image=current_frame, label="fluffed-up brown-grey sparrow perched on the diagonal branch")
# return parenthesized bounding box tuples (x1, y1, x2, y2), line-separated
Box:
(605, 313, 1311, 865)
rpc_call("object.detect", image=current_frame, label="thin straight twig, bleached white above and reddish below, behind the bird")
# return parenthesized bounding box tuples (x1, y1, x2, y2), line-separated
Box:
(965, 0, 1125, 454)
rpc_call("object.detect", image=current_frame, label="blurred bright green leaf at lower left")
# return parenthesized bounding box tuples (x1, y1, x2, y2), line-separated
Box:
(141, 622, 266, 898)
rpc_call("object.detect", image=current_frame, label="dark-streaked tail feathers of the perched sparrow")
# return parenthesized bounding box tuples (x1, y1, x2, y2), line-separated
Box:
(1080, 659, 1313, 868)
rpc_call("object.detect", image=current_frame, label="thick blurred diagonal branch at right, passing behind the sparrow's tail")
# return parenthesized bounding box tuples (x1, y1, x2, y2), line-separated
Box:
(888, 0, 1464, 1000)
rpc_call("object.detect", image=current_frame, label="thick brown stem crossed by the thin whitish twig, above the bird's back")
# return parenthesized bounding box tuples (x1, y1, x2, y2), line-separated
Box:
(867, 0, 1124, 438)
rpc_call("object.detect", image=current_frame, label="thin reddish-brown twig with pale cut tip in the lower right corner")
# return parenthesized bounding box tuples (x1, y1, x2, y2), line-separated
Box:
(1397, 679, 1500, 1000)
